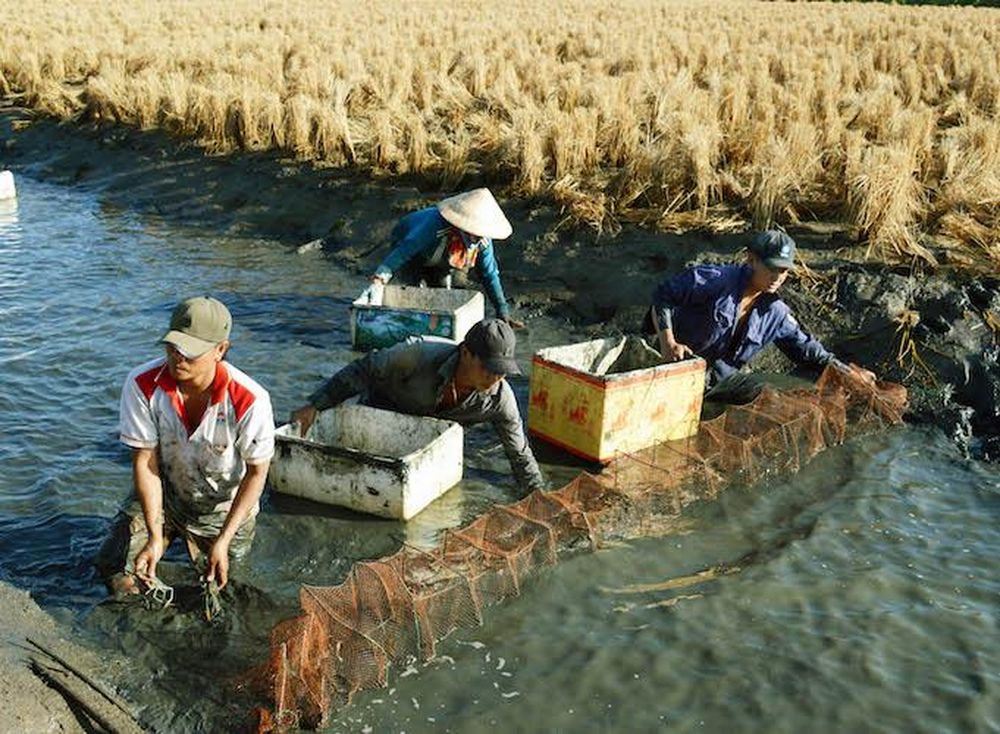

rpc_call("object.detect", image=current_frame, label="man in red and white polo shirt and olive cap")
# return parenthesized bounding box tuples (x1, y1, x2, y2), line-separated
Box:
(98, 297, 274, 592)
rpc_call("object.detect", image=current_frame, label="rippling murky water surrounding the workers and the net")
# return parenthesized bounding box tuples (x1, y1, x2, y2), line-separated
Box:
(0, 176, 1000, 732)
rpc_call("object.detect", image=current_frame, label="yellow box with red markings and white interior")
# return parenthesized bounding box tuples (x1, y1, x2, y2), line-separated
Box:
(528, 337, 705, 463)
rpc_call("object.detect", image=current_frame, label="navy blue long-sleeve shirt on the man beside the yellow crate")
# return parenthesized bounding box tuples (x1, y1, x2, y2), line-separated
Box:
(653, 265, 835, 379)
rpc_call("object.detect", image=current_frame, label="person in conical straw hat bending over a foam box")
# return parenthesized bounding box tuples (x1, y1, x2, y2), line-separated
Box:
(372, 189, 524, 328)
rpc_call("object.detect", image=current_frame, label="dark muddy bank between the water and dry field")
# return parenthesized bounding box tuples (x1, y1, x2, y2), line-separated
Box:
(0, 108, 1000, 459)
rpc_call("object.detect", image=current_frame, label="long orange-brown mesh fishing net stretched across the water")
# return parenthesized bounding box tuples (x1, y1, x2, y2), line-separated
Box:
(247, 368, 906, 731)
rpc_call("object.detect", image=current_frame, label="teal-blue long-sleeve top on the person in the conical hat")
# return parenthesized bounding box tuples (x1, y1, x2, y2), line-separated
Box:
(375, 206, 510, 318)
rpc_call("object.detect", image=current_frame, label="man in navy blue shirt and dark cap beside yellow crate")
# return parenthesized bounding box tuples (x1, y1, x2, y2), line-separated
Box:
(647, 230, 875, 404)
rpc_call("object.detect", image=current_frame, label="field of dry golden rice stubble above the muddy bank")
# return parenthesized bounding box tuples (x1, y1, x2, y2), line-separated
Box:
(0, 0, 1000, 261)
